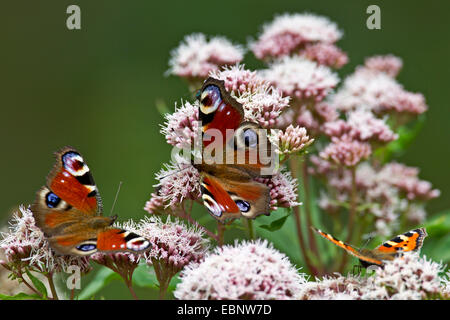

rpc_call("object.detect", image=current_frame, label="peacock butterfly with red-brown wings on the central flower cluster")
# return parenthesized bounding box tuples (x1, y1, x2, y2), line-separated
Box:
(194, 77, 272, 222)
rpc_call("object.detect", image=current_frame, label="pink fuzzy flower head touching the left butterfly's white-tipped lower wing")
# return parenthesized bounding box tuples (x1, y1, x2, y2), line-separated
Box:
(137, 216, 209, 272)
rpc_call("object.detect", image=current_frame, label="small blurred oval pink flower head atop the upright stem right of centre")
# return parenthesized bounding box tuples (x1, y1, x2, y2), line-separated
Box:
(320, 135, 372, 167)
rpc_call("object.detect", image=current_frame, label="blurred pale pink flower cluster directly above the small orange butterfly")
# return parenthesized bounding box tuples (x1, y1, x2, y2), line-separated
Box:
(309, 156, 440, 235)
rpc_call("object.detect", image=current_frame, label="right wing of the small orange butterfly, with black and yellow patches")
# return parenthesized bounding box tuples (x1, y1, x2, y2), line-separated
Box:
(375, 228, 428, 256)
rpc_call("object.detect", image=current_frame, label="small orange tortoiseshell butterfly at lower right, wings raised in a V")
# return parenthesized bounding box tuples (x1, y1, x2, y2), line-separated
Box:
(311, 227, 428, 268)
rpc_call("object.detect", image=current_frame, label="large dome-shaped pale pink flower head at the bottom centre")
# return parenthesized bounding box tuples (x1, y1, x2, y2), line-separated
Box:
(174, 240, 306, 300)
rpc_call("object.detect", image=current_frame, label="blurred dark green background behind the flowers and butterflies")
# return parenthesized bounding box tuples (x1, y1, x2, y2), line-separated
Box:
(0, 0, 450, 300)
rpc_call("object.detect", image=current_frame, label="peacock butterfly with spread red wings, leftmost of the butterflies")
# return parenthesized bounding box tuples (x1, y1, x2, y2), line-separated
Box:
(31, 147, 150, 256)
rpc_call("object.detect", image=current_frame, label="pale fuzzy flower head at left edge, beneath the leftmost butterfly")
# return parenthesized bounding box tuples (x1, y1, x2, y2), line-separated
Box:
(0, 206, 91, 273)
